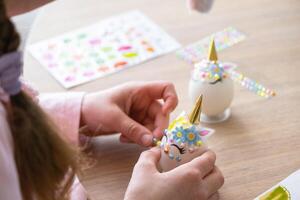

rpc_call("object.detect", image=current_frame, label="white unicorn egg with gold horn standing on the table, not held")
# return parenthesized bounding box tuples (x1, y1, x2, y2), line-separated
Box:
(189, 40, 234, 122)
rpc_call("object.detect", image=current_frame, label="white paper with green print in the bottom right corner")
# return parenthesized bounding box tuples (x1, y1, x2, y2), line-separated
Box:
(254, 170, 300, 200)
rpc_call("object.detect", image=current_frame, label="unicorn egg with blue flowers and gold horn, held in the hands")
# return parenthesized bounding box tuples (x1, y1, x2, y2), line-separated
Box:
(155, 95, 214, 171)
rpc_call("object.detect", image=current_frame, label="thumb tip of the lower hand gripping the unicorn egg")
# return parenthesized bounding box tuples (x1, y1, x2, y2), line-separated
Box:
(136, 147, 160, 172)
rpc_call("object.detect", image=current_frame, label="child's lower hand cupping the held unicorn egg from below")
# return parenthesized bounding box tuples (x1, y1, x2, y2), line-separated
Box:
(125, 147, 224, 200)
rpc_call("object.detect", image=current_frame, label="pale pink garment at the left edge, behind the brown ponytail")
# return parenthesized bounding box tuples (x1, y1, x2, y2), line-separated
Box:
(0, 102, 22, 200)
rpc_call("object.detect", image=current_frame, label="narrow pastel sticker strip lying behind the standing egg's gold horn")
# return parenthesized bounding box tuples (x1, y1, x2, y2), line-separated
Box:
(176, 27, 246, 64)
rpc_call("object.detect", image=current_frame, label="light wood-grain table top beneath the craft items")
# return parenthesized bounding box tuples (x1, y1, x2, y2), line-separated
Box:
(25, 0, 300, 200)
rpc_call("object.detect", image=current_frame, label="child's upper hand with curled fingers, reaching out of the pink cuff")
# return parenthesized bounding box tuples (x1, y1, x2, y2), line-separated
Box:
(81, 81, 178, 146)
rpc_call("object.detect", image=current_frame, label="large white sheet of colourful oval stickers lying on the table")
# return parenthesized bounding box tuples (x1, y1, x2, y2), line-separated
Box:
(29, 11, 180, 88)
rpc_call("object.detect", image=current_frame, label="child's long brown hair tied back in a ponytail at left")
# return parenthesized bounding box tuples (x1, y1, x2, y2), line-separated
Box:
(0, 0, 77, 200)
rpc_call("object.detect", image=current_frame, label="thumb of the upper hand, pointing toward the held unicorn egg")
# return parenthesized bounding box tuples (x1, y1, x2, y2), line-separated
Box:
(116, 113, 153, 146)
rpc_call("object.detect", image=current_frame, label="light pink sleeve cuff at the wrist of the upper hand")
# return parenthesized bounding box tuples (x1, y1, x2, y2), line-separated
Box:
(39, 92, 84, 145)
